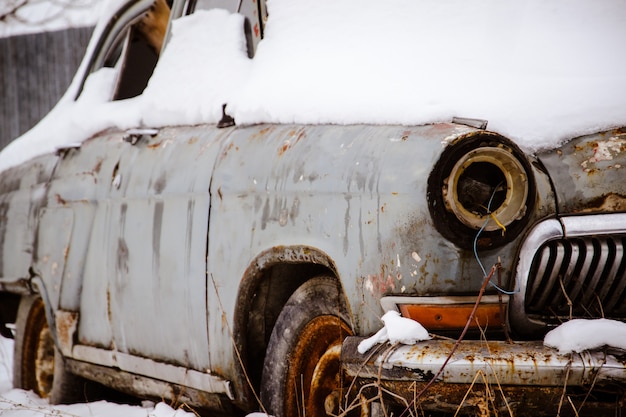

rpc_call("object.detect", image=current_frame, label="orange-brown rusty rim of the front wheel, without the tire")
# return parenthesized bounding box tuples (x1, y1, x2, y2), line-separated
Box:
(285, 316, 352, 417)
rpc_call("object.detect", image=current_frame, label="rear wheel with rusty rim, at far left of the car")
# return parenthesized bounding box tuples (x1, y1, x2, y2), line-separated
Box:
(13, 295, 93, 404)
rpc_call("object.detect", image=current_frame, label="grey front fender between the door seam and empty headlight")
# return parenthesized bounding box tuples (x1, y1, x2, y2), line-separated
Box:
(209, 124, 549, 331)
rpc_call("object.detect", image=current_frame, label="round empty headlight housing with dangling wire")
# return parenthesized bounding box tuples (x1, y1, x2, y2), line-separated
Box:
(428, 132, 535, 249)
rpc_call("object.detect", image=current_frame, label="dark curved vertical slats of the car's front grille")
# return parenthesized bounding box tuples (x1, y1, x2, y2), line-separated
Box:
(525, 235, 626, 322)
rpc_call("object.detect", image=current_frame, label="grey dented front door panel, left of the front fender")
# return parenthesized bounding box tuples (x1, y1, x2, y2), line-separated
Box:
(79, 124, 228, 372)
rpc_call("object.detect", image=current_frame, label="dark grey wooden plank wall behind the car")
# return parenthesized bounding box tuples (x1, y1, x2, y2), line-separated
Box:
(0, 27, 93, 149)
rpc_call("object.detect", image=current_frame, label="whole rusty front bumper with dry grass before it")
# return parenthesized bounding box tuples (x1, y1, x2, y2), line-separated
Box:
(342, 337, 626, 416)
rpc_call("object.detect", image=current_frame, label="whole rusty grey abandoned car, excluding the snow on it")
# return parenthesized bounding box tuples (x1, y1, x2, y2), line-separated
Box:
(0, 0, 626, 417)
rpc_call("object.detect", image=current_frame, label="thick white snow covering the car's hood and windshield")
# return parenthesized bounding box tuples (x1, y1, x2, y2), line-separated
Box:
(0, 0, 626, 169)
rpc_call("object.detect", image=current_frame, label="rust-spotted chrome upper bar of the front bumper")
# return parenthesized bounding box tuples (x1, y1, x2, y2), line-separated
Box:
(341, 337, 626, 387)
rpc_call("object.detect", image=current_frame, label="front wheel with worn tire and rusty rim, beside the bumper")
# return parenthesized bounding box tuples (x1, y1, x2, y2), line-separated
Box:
(261, 276, 352, 417)
